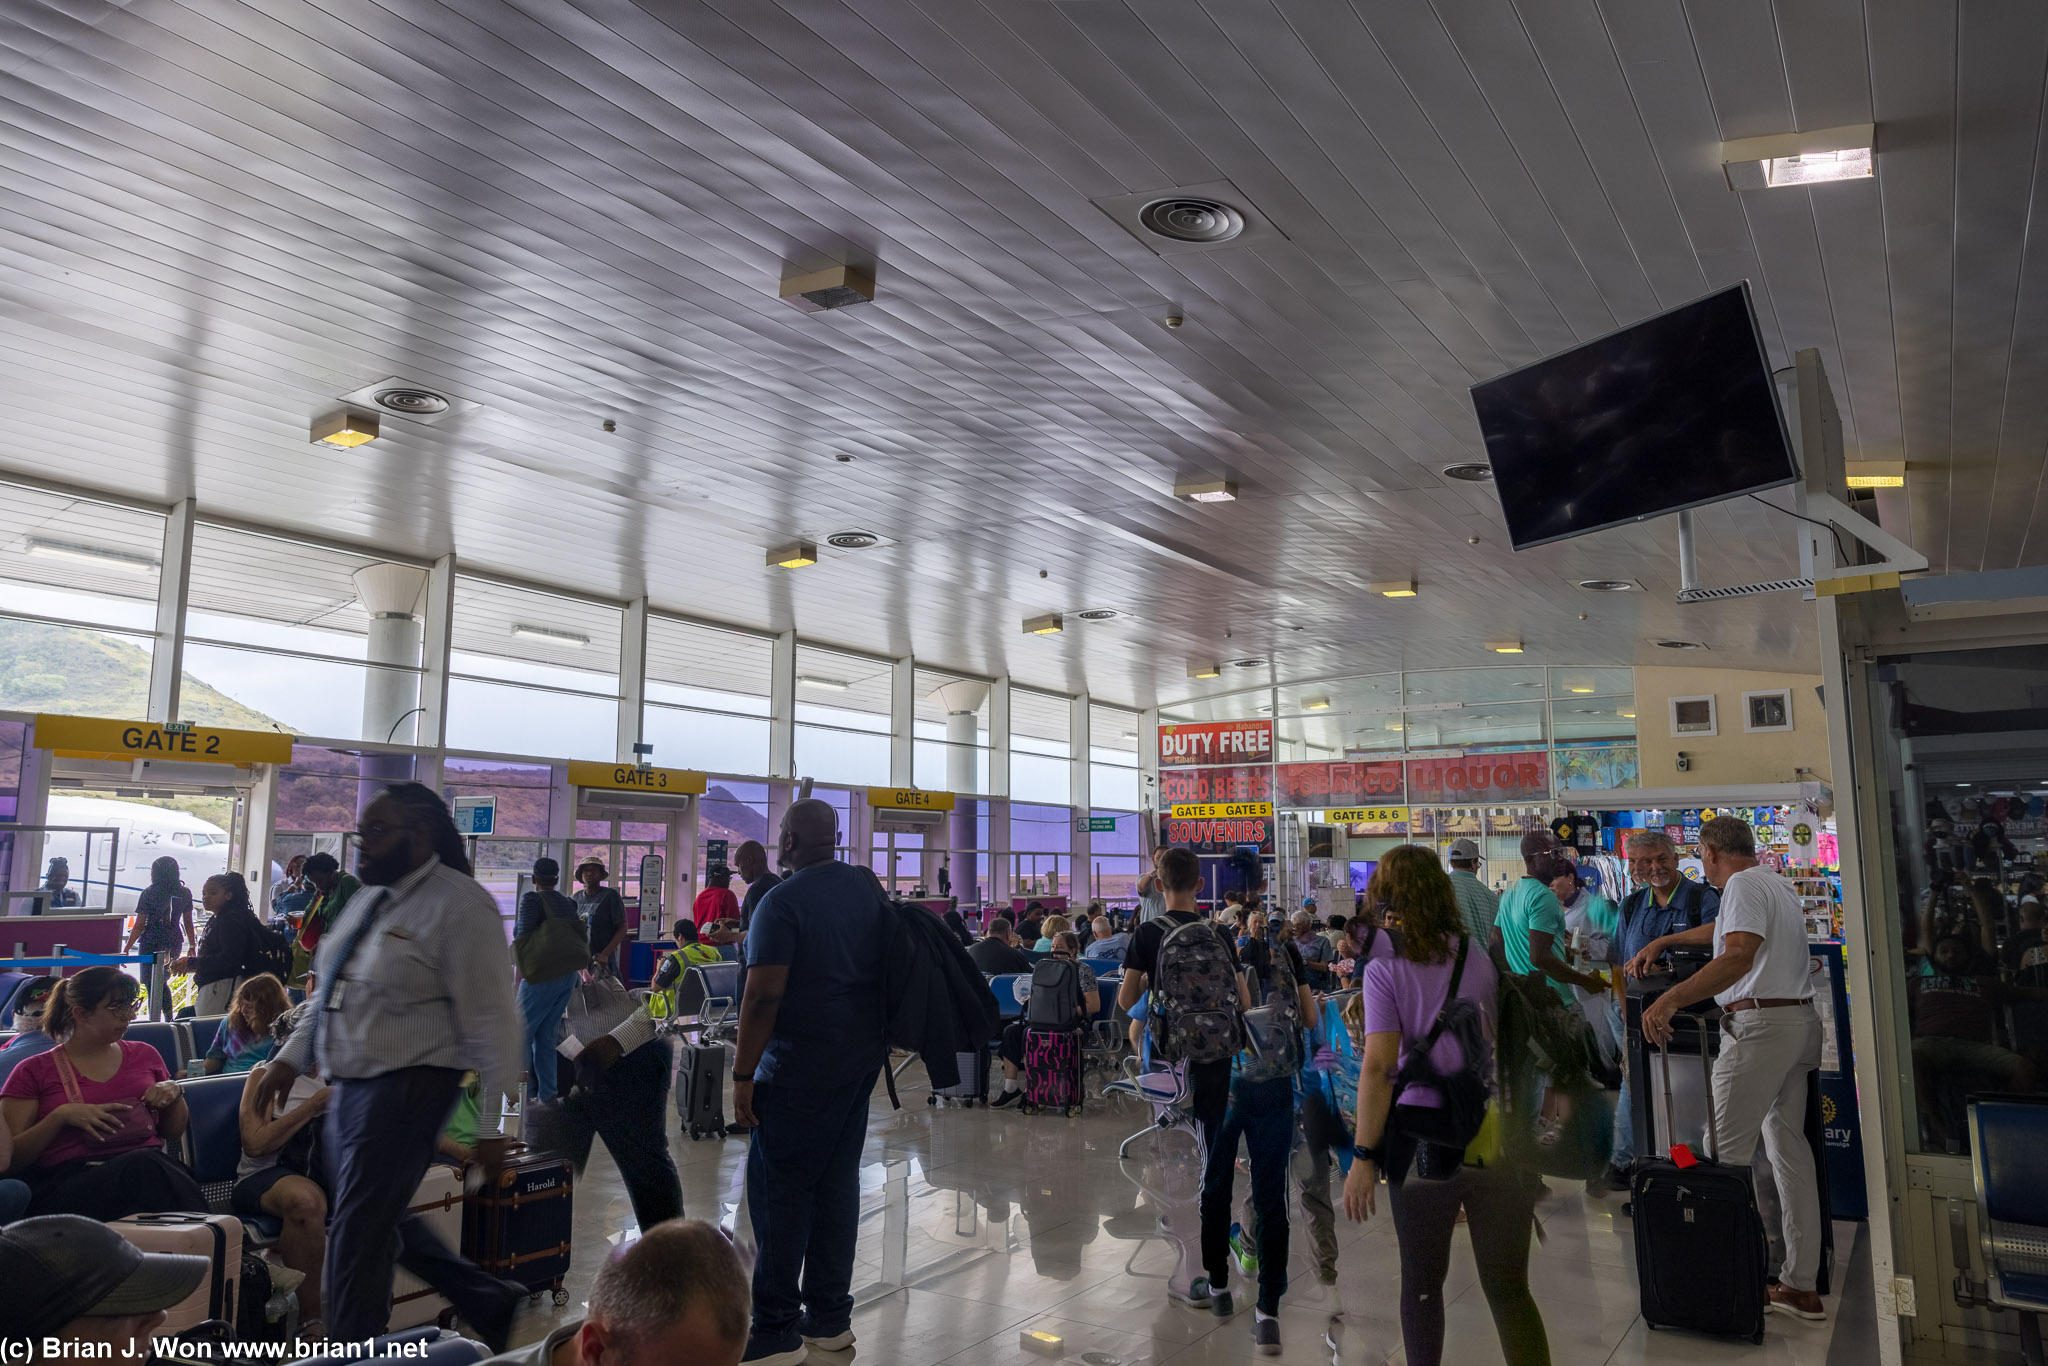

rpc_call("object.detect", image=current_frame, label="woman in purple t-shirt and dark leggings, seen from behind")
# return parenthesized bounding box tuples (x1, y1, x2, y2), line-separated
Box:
(1343, 844, 1550, 1366)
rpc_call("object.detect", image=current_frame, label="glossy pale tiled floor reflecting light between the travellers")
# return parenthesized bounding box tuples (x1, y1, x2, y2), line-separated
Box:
(503, 1067, 1874, 1366)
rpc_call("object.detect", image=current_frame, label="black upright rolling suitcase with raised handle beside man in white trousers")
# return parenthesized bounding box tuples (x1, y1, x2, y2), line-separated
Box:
(1630, 1014, 1769, 1341)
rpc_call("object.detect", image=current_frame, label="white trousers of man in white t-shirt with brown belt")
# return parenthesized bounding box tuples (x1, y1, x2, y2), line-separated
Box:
(1714, 1006, 1823, 1290)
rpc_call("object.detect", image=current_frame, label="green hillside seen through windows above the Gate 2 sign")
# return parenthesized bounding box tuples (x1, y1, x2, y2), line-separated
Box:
(0, 618, 287, 731)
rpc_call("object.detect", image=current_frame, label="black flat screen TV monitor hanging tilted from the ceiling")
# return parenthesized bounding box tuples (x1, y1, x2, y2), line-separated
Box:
(1473, 283, 1798, 551)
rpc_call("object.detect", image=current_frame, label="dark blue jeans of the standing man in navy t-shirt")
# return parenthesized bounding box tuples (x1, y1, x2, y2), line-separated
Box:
(748, 1069, 881, 1354)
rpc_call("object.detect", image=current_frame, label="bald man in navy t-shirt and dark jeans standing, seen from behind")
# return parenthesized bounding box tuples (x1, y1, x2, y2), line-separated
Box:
(733, 799, 893, 1366)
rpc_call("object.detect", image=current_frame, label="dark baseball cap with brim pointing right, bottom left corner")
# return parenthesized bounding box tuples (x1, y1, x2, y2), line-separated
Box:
(0, 1214, 213, 1337)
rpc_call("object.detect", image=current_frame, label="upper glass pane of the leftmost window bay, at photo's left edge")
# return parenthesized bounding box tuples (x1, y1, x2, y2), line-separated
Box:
(0, 483, 164, 634)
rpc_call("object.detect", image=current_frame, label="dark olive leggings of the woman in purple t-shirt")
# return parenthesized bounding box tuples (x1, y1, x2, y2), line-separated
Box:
(1386, 1167, 1550, 1366)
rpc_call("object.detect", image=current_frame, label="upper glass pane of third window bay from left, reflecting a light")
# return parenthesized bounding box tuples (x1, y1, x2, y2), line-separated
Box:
(451, 573, 625, 696)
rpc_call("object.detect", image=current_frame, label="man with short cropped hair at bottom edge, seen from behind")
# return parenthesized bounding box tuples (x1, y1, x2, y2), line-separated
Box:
(483, 1219, 748, 1366)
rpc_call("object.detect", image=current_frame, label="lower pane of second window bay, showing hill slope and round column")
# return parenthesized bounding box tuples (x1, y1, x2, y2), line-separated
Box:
(178, 643, 420, 743)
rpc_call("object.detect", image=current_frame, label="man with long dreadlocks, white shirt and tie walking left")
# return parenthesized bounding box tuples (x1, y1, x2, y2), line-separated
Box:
(256, 782, 526, 1352)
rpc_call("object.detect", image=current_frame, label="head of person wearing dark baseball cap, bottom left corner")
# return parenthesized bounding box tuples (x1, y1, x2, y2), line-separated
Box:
(0, 1214, 213, 1362)
